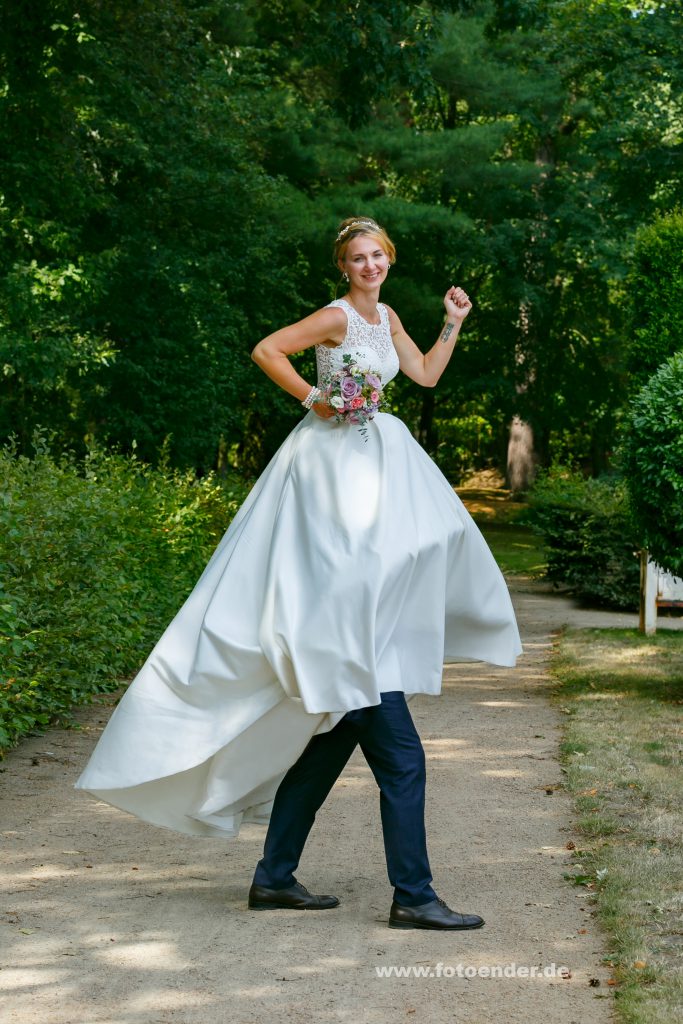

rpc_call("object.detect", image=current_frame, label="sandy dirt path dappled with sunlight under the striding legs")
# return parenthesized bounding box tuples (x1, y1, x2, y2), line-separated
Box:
(0, 590, 679, 1024)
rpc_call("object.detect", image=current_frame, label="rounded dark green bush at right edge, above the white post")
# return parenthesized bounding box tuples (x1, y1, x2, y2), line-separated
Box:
(623, 349, 683, 577)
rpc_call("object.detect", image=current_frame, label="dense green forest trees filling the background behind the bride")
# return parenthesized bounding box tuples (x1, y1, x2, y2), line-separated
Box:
(0, 0, 683, 483)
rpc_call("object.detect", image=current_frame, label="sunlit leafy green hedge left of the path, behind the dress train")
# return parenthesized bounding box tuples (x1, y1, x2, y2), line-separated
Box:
(0, 440, 248, 751)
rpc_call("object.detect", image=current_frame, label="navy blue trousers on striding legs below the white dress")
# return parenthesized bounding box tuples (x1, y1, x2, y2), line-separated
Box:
(254, 691, 436, 906)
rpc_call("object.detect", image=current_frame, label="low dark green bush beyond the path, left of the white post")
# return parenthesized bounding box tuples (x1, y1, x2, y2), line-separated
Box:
(527, 466, 640, 609)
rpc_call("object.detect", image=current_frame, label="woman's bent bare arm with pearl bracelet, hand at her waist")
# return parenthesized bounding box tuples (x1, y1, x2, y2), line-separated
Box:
(251, 306, 346, 419)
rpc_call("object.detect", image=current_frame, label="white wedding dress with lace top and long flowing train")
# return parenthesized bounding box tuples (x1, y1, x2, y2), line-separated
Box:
(76, 299, 521, 837)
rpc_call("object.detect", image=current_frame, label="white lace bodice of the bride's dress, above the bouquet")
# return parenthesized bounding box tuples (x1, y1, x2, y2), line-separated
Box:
(315, 299, 398, 387)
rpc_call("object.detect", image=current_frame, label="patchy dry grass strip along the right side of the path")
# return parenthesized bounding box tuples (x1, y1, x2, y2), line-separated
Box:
(553, 630, 683, 1024)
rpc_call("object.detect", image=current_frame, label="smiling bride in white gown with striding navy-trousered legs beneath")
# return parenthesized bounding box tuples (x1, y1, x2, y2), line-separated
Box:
(76, 216, 521, 930)
